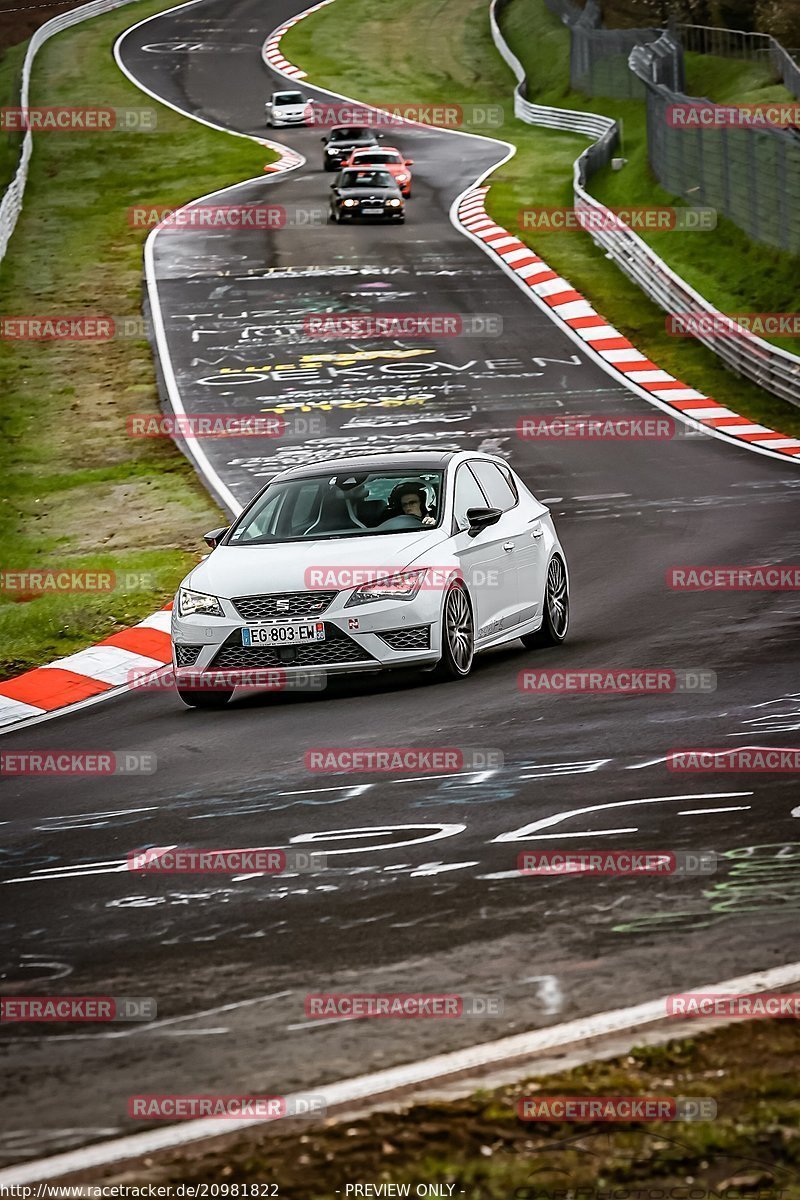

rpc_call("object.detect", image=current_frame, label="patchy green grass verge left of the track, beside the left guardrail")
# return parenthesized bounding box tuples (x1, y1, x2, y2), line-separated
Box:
(0, 0, 272, 677)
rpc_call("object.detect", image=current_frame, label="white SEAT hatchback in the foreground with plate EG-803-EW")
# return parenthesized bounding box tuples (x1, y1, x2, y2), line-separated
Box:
(172, 451, 570, 708)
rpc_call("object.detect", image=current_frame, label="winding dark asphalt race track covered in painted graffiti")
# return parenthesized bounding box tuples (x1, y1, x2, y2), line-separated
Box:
(0, 0, 800, 1165)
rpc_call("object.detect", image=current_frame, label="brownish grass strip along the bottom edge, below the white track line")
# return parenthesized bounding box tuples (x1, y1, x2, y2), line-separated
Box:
(103, 1020, 800, 1200)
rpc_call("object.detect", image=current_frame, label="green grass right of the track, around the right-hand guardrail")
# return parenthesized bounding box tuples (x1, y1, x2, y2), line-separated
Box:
(282, 0, 800, 434)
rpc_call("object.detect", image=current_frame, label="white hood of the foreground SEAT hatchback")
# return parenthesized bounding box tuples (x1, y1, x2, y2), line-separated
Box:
(184, 529, 447, 600)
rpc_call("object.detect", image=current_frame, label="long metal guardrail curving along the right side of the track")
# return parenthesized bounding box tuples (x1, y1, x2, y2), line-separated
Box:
(489, 0, 800, 406)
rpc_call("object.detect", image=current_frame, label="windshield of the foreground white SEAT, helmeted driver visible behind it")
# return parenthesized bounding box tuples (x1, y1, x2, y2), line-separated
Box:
(228, 467, 443, 546)
